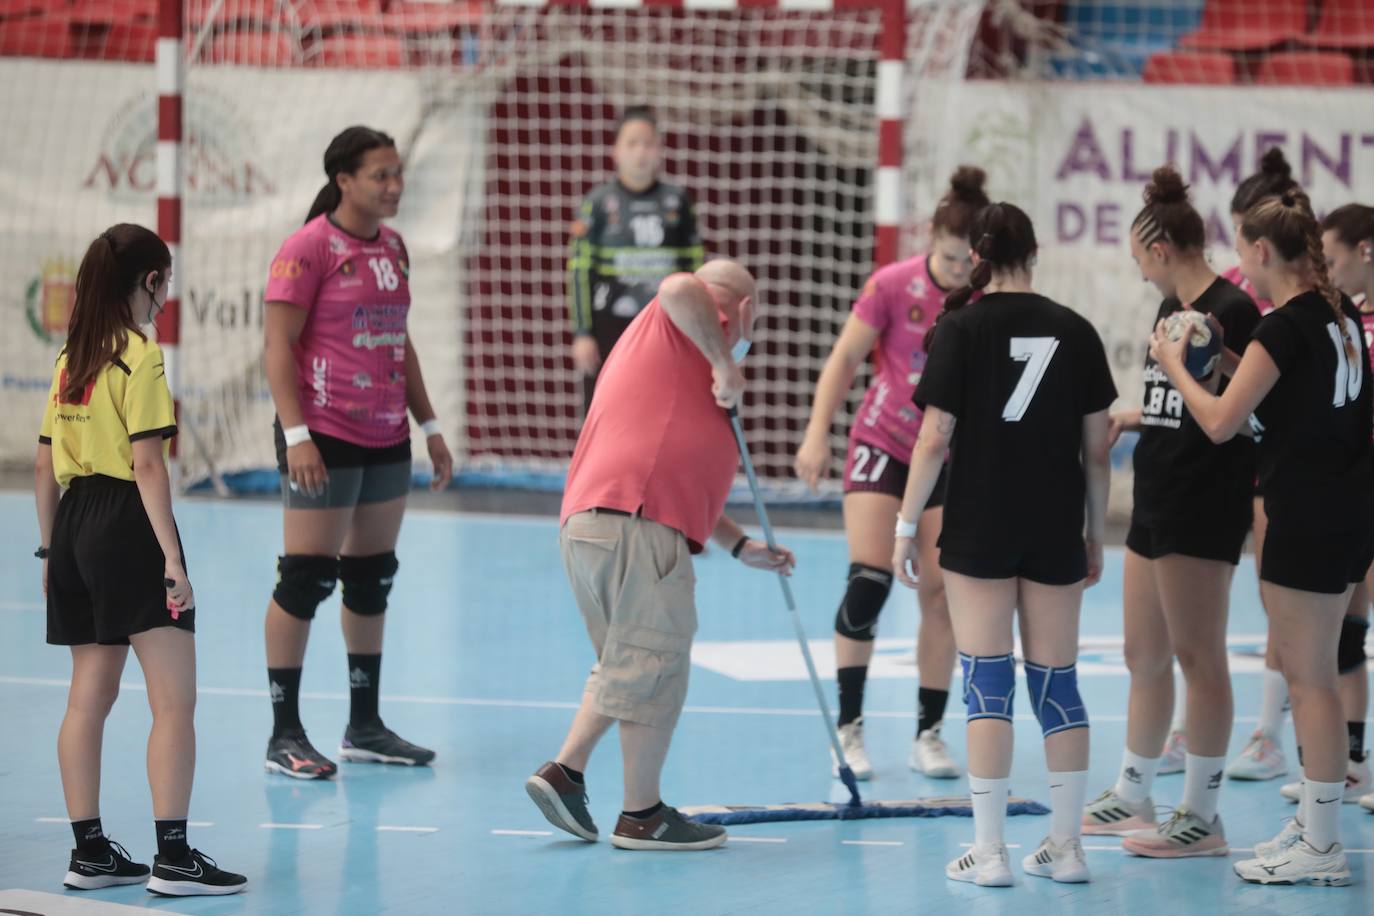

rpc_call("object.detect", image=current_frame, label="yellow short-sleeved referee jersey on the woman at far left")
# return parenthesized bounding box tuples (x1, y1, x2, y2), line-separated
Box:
(38, 332, 176, 486)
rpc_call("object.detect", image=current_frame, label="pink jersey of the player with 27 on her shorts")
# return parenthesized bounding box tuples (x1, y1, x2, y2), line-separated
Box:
(849, 254, 948, 464)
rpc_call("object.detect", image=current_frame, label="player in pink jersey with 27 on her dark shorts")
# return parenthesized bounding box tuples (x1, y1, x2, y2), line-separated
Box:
(794, 165, 988, 779)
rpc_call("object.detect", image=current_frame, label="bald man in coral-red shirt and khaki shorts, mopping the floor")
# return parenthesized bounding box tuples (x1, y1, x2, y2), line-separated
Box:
(525, 261, 796, 850)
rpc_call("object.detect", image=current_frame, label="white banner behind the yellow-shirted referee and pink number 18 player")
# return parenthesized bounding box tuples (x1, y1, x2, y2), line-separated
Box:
(0, 60, 481, 480)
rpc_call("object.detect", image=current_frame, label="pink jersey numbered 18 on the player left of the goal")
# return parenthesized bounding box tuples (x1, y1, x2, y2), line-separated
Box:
(265, 214, 411, 448)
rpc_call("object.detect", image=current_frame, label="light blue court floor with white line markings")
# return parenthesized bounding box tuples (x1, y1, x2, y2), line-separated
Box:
(0, 492, 1374, 916)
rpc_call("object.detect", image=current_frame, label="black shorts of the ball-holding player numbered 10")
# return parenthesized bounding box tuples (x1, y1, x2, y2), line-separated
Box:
(1260, 519, 1374, 595)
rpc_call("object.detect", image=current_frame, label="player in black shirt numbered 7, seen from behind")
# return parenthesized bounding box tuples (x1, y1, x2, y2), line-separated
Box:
(893, 203, 1116, 886)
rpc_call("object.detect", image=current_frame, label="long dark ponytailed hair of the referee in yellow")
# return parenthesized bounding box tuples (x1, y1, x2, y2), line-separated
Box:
(58, 222, 172, 404)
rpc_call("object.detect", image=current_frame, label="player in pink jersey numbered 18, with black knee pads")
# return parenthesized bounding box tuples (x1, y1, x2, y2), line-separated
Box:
(256, 126, 453, 779)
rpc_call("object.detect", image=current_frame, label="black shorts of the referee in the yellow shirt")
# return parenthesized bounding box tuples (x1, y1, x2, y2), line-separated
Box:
(48, 475, 195, 645)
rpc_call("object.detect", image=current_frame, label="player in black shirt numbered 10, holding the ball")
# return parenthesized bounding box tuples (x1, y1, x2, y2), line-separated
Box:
(1150, 191, 1374, 884)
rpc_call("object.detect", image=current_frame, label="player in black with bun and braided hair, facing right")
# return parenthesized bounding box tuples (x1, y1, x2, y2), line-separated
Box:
(1083, 166, 1260, 858)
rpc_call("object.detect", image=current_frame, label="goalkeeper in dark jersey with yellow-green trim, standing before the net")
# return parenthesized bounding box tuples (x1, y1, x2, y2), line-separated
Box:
(567, 106, 705, 405)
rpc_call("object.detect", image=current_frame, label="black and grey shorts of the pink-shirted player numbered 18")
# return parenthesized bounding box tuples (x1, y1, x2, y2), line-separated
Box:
(272, 420, 411, 509)
